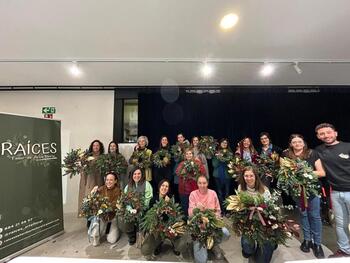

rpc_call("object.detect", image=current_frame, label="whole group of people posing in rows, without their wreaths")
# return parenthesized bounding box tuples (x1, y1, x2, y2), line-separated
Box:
(76, 123, 350, 262)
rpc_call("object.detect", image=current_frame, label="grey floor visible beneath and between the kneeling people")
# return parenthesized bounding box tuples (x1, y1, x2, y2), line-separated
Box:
(24, 214, 336, 263)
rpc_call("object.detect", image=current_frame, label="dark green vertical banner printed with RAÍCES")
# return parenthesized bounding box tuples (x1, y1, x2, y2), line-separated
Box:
(0, 113, 63, 261)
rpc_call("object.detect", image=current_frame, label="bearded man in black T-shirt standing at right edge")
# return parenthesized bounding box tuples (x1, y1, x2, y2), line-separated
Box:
(315, 123, 350, 257)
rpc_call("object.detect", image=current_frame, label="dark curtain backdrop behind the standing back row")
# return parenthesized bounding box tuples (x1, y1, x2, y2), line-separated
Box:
(139, 87, 350, 153)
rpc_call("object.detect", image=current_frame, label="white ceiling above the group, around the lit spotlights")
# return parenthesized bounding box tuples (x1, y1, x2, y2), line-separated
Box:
(0, 0, 350, 86)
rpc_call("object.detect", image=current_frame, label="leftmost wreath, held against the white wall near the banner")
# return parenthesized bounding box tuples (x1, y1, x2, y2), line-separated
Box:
(62, 149, 91, 178)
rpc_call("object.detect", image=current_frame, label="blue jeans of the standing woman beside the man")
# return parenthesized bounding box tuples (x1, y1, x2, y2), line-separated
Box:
(299, 196, 322, 245)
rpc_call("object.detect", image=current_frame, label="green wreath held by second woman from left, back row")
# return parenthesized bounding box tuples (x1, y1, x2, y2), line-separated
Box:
(96, 154, 128, 178)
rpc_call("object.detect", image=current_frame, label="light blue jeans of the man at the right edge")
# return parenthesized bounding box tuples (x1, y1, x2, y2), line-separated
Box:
(331, 191, 350, 254)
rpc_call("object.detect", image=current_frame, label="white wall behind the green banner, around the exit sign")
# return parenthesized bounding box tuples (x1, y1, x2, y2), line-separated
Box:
(0, 91, 114, 213)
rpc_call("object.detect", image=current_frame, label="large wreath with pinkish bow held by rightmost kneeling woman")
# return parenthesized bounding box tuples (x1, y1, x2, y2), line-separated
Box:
(225, 192, 293, 247)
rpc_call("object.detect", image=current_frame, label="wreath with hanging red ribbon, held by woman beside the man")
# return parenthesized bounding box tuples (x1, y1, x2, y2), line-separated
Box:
(277, 158, 319, 209)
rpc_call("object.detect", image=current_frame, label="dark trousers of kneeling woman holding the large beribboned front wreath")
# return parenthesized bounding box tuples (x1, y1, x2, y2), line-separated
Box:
(241, 236, 277, 263)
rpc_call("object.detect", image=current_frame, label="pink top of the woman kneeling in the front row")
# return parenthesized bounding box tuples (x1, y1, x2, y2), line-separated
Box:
(188, 189, 221, 217)
